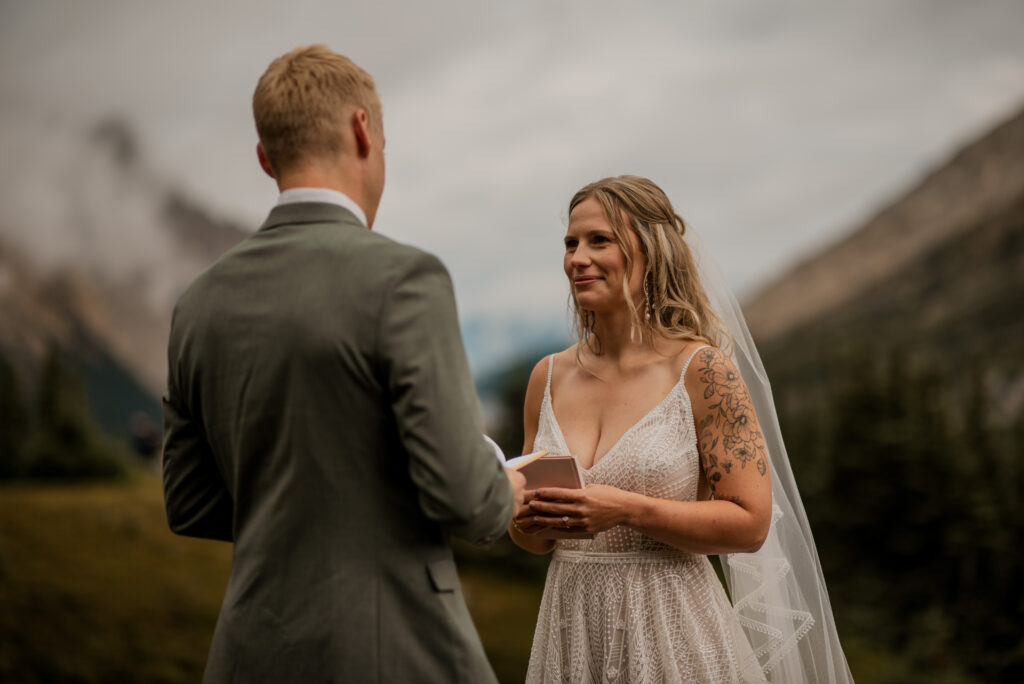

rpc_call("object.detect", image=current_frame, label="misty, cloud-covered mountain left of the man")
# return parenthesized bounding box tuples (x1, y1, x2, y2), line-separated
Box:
(0, 113, 245, 432)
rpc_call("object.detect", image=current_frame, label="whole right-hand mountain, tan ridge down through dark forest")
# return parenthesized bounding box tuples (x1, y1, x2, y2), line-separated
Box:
(745, 104, 1024, 682)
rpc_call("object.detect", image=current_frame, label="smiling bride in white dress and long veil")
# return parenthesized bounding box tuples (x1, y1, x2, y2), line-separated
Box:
(510, 176, 852, 683)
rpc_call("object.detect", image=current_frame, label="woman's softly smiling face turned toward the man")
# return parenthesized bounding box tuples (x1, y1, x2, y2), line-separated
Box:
(562, 198, 644, 312)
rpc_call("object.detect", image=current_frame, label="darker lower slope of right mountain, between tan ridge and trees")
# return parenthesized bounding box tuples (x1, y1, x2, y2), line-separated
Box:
(759, 191, 1024, 395)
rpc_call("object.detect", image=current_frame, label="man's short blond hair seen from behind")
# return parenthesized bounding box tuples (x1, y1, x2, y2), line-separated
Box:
(253, 45, 383, 174)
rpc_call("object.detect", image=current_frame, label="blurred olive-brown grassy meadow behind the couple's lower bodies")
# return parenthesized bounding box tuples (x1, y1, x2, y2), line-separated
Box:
(0, 474, 541, 684)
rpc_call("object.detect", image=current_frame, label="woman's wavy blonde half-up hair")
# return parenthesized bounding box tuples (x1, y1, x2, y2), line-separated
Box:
(569, 175, 730, 347)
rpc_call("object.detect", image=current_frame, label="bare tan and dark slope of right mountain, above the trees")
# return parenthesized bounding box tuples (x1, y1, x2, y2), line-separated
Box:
(743, 105, 1024, 401)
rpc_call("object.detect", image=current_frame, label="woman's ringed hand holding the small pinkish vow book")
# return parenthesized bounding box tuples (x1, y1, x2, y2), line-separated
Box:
(528, 484, 640, 535)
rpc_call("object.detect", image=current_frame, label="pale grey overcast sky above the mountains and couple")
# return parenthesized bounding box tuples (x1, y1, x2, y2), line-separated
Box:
(0, 0, 1024, 374)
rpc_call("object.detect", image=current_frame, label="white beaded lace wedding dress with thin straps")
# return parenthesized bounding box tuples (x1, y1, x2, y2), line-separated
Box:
(526, 352, 765, 684)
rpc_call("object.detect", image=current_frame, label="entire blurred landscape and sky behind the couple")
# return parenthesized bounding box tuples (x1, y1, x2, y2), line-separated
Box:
(0, 0, 1024, 682)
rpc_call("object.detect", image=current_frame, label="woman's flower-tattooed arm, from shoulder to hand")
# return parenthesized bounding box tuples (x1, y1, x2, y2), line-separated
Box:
(519, 348, 771, 554)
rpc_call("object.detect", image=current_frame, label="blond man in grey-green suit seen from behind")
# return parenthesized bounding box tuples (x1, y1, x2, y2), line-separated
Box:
(164, 46, 523, 684)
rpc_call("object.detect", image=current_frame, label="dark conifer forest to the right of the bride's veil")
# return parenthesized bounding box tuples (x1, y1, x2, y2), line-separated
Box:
(780, 350, 1024, 682)
